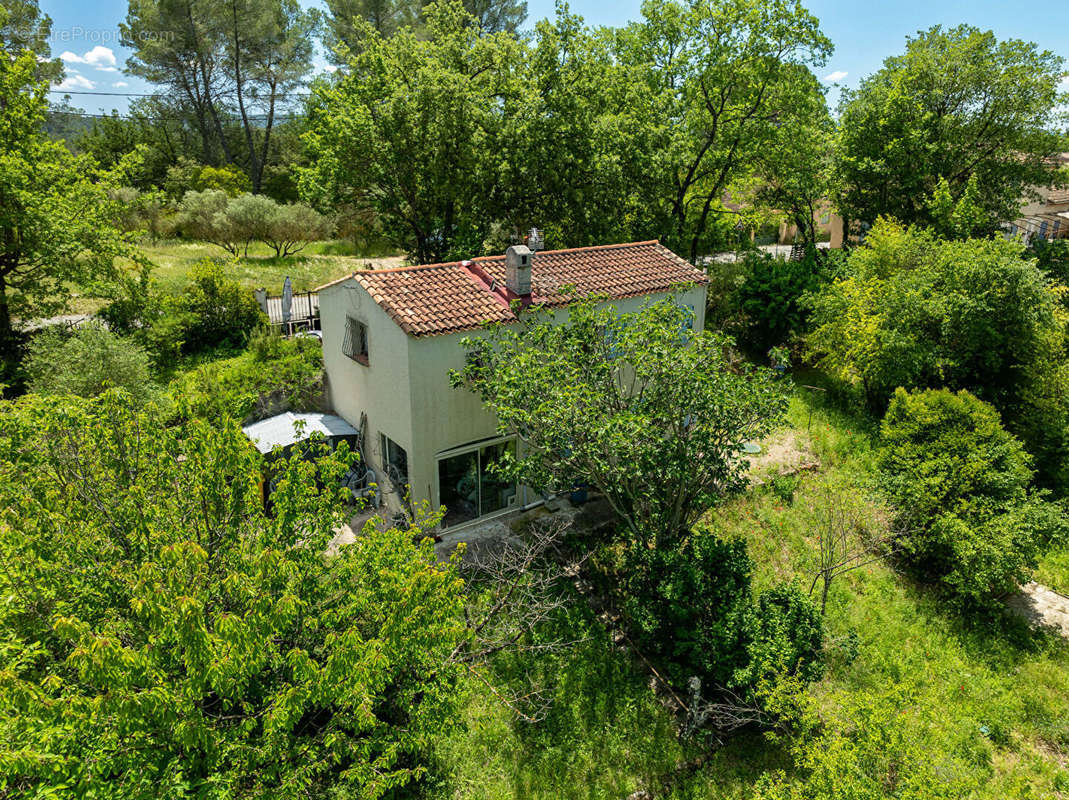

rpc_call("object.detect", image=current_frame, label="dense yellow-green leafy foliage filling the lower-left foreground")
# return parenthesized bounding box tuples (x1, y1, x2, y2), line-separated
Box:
(0, 393, 465, 800)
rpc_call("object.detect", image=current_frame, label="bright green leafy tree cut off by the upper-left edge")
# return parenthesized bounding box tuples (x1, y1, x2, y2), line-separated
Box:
(0, 51, 130, 344)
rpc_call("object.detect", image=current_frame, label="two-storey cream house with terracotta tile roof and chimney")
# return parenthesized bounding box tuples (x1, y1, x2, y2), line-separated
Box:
(319, 242, 707, 527)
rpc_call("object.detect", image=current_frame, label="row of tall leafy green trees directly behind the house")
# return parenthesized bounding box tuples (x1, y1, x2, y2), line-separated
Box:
(301, 0, 831, 262)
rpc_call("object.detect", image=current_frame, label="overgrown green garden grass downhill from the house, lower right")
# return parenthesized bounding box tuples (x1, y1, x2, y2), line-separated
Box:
(434, 389, 1069, 800)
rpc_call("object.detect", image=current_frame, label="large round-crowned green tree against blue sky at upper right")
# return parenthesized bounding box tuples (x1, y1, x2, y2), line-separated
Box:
(837, 26, 1065, 230)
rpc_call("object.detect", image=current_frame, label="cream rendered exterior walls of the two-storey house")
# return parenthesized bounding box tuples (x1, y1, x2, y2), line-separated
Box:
(320, 280, 706, 524)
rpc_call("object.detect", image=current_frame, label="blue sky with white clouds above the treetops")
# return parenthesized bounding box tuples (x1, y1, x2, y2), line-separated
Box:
(41, 0, 1069, 112)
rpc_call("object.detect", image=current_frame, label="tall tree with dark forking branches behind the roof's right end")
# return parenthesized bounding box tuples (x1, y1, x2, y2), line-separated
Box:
(617, 0, 832, 260)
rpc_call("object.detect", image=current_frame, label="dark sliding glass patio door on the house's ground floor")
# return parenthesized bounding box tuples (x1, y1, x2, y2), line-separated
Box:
(438, 442, 517, 527)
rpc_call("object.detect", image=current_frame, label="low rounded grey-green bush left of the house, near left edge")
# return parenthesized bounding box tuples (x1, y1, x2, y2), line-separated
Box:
(25, 322, 152, 401)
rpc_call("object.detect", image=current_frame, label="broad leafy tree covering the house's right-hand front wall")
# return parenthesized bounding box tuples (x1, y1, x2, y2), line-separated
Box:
(452, 298, 785, 542)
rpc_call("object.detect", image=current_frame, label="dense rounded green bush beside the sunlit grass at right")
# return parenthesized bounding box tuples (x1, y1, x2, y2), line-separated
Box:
(880, 389, 1069, 602)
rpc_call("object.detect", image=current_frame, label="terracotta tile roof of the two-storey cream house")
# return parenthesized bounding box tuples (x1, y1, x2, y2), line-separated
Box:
(321, 242, 708, 336)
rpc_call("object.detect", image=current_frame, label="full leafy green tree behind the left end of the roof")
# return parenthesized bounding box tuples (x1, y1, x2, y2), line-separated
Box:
(303, 2, 523, 262)
